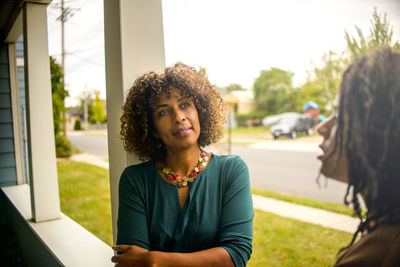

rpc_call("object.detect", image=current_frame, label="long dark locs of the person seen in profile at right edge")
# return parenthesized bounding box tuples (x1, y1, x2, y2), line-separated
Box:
(335, 48, 400, 249)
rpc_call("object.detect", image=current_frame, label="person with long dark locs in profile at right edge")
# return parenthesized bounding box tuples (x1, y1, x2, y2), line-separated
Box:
(318, 48, 400, 266)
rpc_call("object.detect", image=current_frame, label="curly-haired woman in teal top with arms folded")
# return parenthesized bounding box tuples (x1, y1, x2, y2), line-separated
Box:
(112, 63, 253, 266)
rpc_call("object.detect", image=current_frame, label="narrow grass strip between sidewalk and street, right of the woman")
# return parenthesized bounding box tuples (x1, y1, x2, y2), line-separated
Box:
(251, 188, 355, 216)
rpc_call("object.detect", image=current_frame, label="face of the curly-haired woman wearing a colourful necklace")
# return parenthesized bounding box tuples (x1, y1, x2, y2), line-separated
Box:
(153, 92, 200, 151)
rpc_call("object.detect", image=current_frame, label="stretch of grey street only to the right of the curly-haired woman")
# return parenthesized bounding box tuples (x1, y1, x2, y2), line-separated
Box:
(232, 144, 346, 203)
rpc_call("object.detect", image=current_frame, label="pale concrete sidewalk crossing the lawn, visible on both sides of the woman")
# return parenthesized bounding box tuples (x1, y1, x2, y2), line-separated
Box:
(70, 153, 360, 233)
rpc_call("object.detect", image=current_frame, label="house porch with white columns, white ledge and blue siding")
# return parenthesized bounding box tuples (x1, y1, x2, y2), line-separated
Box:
(0, 0, 165, 266)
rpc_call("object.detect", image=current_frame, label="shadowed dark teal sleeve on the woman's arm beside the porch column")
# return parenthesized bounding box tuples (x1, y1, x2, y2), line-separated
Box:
(117, 168, 150, 250)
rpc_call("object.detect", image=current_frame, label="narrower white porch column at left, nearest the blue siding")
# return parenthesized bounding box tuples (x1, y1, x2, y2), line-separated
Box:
(23, 3, 60, 222)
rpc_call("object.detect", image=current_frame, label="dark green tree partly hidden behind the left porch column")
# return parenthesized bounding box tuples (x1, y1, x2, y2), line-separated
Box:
(50, 57, 71, 157)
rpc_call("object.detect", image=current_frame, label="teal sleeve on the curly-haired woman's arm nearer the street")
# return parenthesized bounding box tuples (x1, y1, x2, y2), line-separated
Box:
(219, 157, 254, 266)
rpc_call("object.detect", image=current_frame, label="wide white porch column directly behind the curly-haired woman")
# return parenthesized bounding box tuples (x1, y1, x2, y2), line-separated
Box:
(104, 0, 165, 242)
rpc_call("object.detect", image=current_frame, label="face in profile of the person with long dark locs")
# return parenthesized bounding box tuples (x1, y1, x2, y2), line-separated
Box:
(317, 97, 349, 183)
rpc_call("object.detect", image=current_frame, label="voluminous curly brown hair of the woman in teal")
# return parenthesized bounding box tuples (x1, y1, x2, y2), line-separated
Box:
(120, 63, 225, 162)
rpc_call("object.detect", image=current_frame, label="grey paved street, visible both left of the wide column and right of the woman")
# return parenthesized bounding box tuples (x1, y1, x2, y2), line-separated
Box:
(68, 133, 346, 203)
